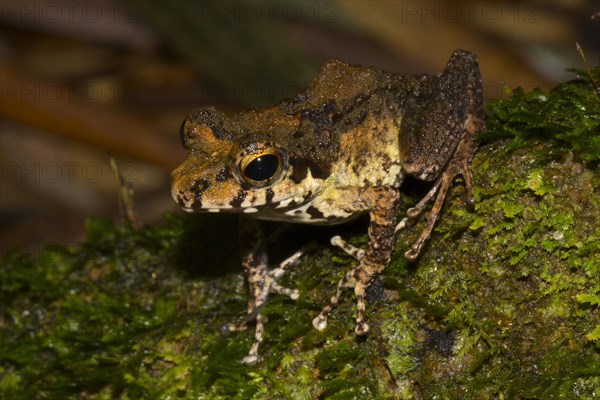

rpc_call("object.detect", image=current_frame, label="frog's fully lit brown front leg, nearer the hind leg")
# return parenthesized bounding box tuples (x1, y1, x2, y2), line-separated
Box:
(313, 186, 399, 335)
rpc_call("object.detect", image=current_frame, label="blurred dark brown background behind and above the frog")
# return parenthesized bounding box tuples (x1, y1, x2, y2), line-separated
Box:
(0, 0, 600, 252)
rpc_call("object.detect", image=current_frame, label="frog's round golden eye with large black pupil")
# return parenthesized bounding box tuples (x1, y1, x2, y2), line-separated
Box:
(240, 147, 285, 187)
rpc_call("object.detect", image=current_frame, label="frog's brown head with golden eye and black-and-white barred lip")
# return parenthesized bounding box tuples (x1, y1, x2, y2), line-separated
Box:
(171, 107, 331, 219)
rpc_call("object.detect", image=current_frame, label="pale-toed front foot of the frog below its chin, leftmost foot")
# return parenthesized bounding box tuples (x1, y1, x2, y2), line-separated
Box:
(221, 246, 308, 365)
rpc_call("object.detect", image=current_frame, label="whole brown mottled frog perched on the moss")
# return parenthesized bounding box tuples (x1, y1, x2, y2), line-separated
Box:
(171, 49, 484, 365)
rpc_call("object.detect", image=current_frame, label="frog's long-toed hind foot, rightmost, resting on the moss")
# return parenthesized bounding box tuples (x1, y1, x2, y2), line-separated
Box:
(406, 128, 476, 260)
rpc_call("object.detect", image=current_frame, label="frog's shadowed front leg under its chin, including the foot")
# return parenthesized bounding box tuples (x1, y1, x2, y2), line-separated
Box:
(222, 218, 306, 365)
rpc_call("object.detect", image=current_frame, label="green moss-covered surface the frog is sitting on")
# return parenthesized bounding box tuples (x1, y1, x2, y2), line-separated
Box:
(0, 69, 600, 399)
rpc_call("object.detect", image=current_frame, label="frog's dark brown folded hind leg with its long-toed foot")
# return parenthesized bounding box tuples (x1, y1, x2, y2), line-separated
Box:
(400, 50, 484, 260)
